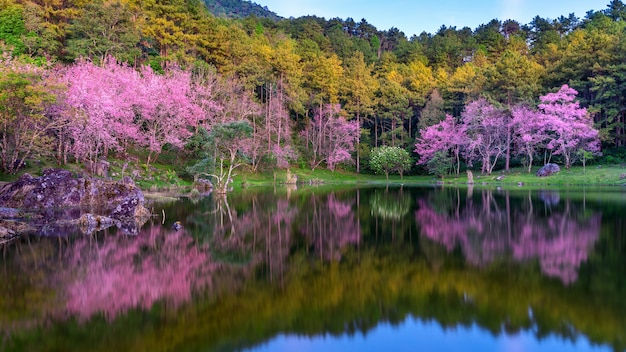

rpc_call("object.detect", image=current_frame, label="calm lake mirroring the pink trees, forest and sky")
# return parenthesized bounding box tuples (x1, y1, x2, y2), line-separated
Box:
(0, 185, 626, 351)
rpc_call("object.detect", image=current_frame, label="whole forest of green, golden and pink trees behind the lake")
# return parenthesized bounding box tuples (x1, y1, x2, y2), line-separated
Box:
(0, 0, 626, 180)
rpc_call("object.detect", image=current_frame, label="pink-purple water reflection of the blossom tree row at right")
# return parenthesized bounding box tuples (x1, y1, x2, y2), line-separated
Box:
(415, 189, 601, 284)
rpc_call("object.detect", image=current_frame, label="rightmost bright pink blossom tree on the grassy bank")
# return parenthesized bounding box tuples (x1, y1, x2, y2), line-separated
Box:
(539, 85, 600, 168)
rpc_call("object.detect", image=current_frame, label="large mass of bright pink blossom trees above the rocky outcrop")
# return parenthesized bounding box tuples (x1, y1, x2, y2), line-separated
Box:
(62, 58, 219, 169)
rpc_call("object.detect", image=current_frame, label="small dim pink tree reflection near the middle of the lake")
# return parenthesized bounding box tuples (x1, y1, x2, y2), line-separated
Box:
(301, 194, 361, 260)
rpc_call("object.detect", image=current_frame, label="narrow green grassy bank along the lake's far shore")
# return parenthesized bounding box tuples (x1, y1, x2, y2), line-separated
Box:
(0, 160, 626, 192)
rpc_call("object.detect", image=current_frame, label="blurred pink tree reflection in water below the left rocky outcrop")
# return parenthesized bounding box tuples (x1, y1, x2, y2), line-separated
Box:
(66, 225, 215, 320)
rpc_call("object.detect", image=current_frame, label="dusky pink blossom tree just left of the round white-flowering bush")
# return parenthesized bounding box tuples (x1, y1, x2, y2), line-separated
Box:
(302, 104, 359, 170)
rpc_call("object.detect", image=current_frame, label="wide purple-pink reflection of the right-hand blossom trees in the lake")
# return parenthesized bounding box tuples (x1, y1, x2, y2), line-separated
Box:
(415, 193, 600, 284)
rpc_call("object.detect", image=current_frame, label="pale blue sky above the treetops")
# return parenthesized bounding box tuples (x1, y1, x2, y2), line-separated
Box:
(251, 0, 611, 38)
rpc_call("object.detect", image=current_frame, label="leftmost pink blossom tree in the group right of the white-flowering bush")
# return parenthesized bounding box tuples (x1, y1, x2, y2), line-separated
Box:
(415, 115, 467, 174)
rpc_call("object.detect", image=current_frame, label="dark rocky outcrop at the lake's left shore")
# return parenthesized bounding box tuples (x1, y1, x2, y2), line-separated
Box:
(0, 169, 150, 235)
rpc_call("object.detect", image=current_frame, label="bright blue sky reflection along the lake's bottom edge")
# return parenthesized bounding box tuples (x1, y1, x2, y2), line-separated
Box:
(247, 318, 611, 352)
